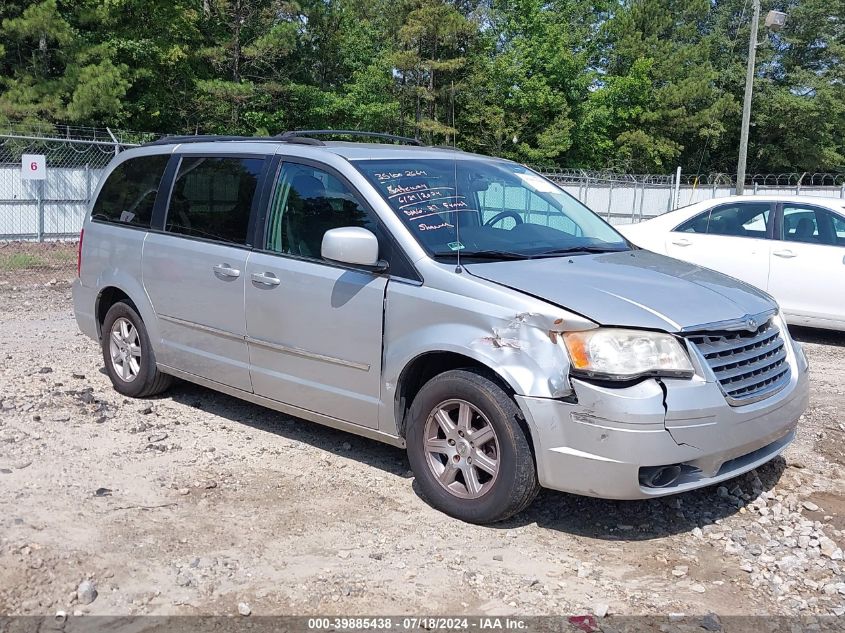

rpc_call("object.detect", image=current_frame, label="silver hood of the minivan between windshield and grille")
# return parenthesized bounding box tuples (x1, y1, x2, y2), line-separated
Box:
(465, 250, 777, 332)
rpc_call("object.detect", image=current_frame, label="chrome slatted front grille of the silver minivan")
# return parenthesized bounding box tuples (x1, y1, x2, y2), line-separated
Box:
(687, 320, 790, 406)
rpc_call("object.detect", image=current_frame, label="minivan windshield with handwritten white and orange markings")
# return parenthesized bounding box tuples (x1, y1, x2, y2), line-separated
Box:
(354, 158, 630, 260)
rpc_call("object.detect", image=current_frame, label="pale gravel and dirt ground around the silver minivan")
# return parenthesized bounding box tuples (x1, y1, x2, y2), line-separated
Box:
(0, 282, 845, 616)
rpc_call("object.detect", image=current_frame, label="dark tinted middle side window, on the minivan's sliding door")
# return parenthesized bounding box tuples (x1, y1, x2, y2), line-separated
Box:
(166, 156, 264, 244)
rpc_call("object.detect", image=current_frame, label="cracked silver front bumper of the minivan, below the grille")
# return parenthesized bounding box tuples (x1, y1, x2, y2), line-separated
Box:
(517, 346, 809, 499)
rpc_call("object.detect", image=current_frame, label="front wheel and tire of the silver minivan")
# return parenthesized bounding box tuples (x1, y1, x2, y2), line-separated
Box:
(405, 369, 540, 524)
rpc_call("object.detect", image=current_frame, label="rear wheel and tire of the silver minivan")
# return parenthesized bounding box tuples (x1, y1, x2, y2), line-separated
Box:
(100, 301, 173, 398)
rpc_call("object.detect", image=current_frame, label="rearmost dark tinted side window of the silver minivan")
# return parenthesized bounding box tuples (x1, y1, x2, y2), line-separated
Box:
(91, 155, 169, 228)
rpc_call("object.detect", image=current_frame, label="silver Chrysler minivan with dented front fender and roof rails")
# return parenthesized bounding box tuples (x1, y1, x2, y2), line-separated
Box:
(73, 131, 808, 523)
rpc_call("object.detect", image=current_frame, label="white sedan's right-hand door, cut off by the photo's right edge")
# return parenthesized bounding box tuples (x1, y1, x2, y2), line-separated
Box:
(768, 202, 845, 325)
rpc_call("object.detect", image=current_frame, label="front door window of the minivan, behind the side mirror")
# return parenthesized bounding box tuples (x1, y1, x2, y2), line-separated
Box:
(265, 163, 377, 259)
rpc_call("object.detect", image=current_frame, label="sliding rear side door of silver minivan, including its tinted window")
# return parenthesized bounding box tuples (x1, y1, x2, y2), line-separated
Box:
(142, 155, 264, 391)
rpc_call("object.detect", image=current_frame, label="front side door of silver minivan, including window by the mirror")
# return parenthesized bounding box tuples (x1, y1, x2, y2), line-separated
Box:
(245, 162, 387, 428)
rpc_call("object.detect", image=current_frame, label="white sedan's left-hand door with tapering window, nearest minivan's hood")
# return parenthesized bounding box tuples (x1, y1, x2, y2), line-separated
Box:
(666, 202, 773, 290)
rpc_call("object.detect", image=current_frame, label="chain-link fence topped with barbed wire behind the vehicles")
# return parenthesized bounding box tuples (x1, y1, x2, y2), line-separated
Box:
(0, 126, 845, 285)
